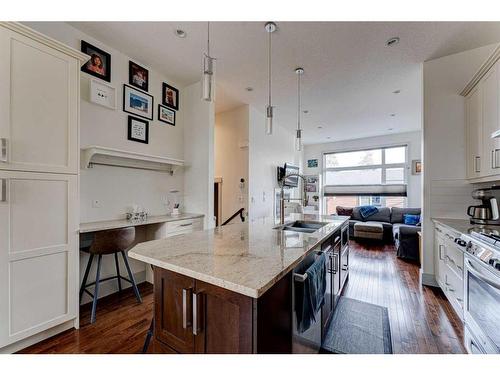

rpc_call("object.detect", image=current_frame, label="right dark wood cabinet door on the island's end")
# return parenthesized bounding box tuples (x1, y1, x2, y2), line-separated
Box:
(193, 280, 252, 353)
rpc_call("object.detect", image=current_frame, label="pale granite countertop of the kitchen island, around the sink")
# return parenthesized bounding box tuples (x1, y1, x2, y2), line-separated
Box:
(128, 214, 348, 298)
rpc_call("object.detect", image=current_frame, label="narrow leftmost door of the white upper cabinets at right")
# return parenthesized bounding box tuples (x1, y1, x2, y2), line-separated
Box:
(465, 86, 484, 178)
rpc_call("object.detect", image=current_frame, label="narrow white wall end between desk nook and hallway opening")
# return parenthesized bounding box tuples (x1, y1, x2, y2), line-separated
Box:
(183, 82, 215, 228)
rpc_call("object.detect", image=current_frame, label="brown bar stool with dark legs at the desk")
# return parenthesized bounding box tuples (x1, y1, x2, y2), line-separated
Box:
(80, 227, 142, 323)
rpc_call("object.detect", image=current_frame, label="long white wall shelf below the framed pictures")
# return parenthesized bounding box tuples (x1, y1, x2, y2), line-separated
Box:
(80, 146, 184, 175)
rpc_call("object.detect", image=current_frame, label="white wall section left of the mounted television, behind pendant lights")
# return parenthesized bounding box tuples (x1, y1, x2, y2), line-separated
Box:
(248, 107, 301, 220)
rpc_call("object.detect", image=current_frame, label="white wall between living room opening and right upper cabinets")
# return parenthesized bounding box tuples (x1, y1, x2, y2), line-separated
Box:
(422, 45, 495, 285)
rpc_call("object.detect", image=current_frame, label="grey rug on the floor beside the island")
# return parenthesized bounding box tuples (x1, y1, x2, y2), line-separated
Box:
(322, 297, 392, 354)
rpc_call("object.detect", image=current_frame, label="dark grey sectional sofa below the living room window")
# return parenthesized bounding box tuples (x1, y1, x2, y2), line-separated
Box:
(337, 206, 421, 261)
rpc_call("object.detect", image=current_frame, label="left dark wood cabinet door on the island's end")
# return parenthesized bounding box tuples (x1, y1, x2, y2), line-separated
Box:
(155, 267, 195, 353)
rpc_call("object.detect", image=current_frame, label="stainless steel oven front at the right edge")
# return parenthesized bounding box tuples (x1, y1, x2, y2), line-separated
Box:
(464, 253, 500, 353)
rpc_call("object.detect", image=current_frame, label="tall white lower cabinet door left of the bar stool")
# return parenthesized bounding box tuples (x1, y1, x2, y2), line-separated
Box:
(0, 171, 78, 348)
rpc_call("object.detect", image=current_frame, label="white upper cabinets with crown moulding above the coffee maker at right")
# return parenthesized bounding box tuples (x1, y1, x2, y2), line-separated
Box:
(461, 47, 500, 182)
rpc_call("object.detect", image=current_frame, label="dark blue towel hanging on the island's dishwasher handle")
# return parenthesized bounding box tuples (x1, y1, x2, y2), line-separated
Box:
(295, 253, 326, 333)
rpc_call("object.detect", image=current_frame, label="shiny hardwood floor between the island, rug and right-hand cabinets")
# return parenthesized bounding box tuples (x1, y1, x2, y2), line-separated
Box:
(344, 241, 465, 354)
